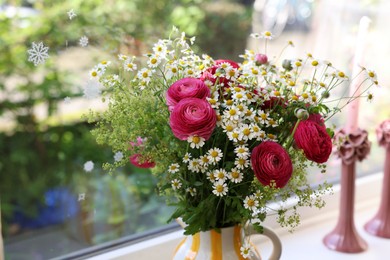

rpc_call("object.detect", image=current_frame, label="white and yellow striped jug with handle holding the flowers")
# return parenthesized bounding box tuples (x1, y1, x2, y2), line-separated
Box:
(173, 225, 282, 260)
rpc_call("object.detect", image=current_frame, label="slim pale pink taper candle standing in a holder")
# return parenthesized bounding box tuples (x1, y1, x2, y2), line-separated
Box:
(346, 16, 371, 133)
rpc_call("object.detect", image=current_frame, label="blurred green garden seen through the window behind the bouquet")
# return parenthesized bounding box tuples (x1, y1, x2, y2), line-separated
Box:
(0, 0, 253, 259)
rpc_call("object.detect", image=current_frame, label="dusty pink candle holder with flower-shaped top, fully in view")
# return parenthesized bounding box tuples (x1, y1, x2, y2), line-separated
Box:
(323, 129, 371, 253)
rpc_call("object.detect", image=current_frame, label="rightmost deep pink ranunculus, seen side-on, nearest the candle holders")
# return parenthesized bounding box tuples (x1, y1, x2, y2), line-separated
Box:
(294, 116, 332, 163)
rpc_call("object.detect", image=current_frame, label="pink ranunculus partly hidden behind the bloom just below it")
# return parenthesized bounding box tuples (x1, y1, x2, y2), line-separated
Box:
(166, 78, 210, 111)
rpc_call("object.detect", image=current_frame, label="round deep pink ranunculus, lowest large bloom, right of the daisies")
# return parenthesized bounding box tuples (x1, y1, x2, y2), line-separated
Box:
(251, 141, 293, 188)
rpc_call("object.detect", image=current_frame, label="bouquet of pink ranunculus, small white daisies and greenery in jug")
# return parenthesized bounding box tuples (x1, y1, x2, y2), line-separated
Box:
(87, 29, 377, 234)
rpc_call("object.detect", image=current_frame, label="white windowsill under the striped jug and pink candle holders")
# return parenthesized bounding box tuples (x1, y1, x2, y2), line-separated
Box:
(89, 173, 389, 260)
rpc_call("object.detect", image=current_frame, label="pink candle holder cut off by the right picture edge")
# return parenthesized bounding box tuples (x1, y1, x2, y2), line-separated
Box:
(364, 120, 390, 238)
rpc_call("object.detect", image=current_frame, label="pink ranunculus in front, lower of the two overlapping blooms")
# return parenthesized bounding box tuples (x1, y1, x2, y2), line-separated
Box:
(169, 98, 217, 140)
